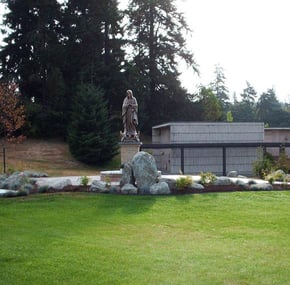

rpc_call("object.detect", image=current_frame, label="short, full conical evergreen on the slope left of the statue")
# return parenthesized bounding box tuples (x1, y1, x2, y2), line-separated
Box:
(68, 84, 117, 164)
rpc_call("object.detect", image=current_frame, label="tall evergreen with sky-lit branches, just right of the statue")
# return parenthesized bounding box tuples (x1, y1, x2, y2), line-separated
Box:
(127, 0, 196, 128)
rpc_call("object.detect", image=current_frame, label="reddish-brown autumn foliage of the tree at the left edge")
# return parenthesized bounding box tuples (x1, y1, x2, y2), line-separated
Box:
(0, 83, 25, 141)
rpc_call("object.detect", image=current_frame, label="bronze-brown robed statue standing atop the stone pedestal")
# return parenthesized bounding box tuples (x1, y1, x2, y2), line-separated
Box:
(120, 90, 139, 142)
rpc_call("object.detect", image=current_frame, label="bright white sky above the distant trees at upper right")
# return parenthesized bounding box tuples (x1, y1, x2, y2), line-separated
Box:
(0, 0, 290, 102)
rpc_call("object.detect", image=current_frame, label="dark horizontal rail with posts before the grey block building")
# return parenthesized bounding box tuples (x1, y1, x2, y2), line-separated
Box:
(140, 142, 290, 176)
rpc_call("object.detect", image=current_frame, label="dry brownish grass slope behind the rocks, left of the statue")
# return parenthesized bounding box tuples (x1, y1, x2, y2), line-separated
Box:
(0, 139, 120, 176)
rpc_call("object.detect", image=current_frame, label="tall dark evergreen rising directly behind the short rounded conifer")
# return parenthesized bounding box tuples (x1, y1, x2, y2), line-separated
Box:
(62, 0, 124, 115)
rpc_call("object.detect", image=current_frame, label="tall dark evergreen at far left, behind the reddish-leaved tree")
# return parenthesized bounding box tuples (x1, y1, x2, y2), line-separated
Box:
(0, 0, 67, 135)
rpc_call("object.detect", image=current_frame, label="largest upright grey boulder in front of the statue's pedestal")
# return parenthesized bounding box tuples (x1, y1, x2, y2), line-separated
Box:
(132, 151, 158, 194)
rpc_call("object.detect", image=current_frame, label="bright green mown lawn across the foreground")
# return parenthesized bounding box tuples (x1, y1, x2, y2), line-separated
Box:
(0, 191, 290, 285)
